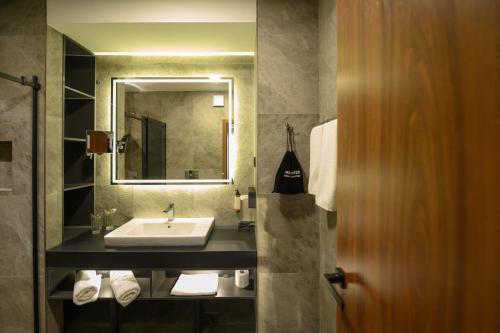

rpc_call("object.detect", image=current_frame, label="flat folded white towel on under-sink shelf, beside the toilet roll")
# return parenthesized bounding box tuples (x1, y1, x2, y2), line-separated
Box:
(171, 273, 219, 296)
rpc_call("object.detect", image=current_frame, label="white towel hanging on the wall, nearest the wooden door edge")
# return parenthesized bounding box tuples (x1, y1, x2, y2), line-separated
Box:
(316, 119, 337, 211)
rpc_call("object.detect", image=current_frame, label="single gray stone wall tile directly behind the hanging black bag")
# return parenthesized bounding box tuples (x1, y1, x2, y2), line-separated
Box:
(257, 114, 318, 194)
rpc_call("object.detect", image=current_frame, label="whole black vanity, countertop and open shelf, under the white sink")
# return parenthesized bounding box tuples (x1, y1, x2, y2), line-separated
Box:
(46, 227, 257, 332)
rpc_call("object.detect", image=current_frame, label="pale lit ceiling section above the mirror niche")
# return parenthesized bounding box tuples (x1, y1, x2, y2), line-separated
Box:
(47, 0, 256, 55)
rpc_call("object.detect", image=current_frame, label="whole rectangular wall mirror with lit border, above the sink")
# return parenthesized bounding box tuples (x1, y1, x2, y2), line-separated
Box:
(111, 77, 234, 184)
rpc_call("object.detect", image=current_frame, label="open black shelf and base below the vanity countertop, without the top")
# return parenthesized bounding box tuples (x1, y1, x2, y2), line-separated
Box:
(48, 269, 256, 333)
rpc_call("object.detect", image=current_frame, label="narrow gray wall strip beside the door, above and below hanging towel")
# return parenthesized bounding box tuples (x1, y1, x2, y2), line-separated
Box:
(317, 0, 337, 333)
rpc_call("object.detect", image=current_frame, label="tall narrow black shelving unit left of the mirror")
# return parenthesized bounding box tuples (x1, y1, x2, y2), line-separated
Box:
(63, 36, 95, 240)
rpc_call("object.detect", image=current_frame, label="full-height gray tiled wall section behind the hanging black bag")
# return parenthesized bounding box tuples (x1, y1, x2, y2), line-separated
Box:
(257, 0, 319, 333)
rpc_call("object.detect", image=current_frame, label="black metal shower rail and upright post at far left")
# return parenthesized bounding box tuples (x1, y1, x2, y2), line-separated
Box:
(0, 72, 41, 333)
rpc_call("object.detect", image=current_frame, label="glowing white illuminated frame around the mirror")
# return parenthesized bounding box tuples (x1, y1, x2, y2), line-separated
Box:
(111, 75, 236, 185)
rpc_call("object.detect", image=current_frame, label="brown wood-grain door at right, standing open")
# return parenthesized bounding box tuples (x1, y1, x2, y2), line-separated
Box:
(337, 0, 500, 333)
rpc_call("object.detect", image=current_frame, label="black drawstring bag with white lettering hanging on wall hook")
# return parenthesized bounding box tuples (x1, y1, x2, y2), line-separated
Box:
(273, 123, 305, 194)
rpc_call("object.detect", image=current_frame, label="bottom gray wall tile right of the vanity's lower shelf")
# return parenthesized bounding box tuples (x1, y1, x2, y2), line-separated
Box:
(257, 273, 319, 333)
